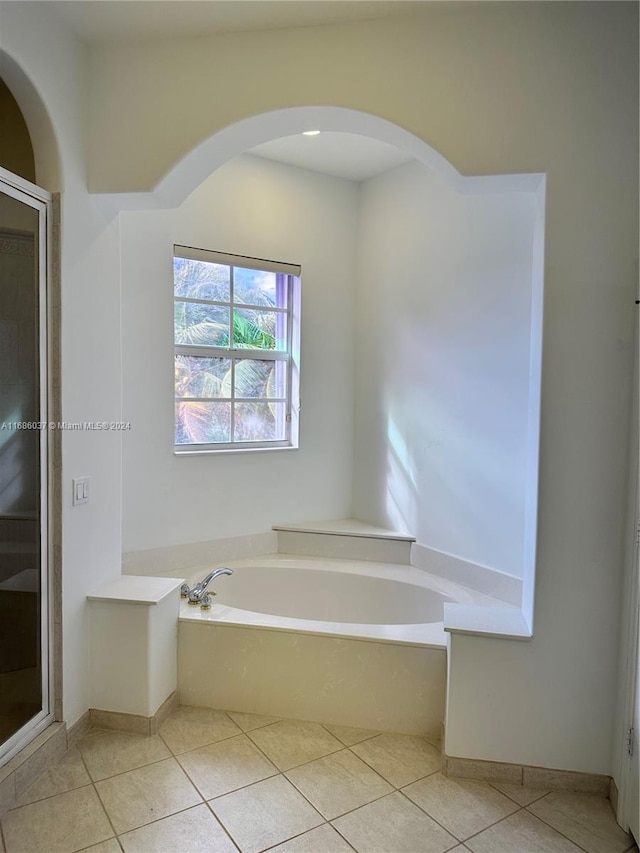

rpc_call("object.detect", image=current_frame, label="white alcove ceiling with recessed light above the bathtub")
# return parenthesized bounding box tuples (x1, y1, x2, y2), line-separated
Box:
(248, 131, 412, 181)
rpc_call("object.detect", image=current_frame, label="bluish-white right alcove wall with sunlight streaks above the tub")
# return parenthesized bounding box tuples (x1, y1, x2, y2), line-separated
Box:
(354, 163, 537, 578)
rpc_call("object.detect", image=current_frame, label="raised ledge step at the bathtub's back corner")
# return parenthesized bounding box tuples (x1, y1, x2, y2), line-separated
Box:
(273, 518, 415, 565)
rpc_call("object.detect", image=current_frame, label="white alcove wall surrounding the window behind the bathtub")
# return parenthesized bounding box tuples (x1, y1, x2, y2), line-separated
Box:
(121, 155, 357, 552)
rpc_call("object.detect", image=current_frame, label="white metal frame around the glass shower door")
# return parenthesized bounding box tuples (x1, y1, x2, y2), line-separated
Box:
(0, 167, 54, 767)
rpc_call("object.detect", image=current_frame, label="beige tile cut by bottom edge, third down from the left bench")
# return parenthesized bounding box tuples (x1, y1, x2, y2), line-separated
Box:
(120, 805, 237, 853)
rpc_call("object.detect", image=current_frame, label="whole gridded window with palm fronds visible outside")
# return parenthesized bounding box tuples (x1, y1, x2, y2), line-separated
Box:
(173, 246, 300, 452)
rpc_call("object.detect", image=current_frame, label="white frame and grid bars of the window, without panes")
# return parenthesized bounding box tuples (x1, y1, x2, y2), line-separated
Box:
(173, 244, 301, 455)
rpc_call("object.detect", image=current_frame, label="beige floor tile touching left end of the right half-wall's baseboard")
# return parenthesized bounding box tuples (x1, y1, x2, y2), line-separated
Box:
(402, 773, 519, 841)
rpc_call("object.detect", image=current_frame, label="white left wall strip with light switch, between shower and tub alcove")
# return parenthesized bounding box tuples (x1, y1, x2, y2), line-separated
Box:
(0, 3, 122, 724)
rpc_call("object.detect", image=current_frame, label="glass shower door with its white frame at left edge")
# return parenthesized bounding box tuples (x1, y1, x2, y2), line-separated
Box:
(0, 169, 52, 765)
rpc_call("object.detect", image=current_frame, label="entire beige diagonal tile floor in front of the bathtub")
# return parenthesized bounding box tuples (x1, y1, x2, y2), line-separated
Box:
(0, 707, 637, 853)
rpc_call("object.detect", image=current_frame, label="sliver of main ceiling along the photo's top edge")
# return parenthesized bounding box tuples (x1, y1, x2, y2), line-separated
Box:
(47, 0, 420, 44)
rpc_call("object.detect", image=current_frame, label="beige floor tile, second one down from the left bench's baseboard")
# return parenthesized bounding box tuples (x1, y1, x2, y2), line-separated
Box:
(96, 758, 202, 835)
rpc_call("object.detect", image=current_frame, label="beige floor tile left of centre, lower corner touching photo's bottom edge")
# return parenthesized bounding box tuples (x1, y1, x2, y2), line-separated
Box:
(209, 776, 323, 853)
